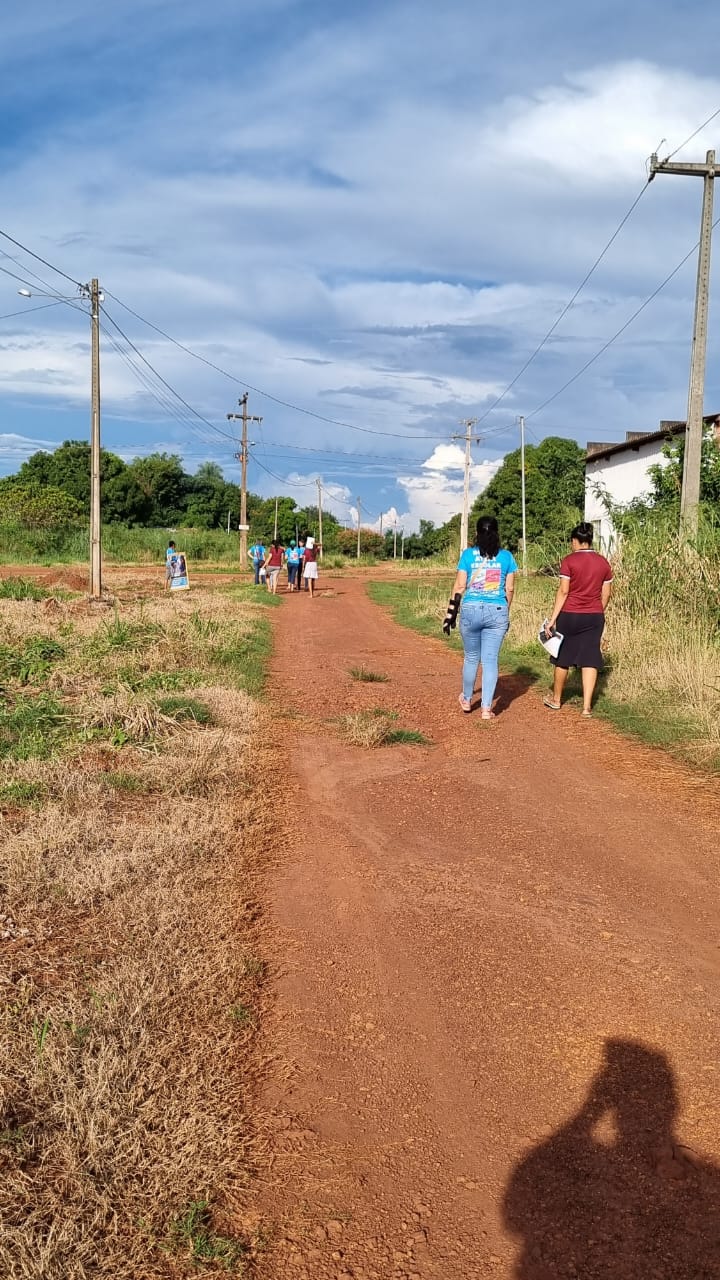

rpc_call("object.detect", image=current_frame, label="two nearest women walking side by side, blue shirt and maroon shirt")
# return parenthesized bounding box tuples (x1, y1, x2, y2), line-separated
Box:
(442, 516, 612, 719)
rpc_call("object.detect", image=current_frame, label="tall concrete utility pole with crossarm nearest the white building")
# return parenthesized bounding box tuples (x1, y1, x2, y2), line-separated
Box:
(650, 151, 720, 534)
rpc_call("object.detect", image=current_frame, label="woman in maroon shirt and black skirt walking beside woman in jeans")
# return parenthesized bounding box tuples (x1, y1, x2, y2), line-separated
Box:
(543, 522, 612, 716)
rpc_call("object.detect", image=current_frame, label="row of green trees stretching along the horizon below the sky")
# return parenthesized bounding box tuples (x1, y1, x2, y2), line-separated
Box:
(0, 436, 594, 558)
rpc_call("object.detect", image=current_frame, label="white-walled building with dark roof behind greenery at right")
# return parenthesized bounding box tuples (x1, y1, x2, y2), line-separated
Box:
(585, 413, 720, 549)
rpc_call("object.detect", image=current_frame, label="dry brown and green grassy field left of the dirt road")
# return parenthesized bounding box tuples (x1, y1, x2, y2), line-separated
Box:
(0, 582, 275, 1280)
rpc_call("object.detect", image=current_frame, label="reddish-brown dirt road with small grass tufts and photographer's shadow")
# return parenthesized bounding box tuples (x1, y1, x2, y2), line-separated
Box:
(252, 581, 720, 1280)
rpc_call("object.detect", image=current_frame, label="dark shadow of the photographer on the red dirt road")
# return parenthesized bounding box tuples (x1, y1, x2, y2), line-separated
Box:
(503, 1039, 720, 1280)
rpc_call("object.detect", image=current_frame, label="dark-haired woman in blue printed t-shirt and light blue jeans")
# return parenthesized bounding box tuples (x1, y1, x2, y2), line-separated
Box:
(442, 516, 518, 719)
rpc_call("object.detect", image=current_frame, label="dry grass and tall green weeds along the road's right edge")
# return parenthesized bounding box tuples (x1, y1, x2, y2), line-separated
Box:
(369, 513, 720, 771)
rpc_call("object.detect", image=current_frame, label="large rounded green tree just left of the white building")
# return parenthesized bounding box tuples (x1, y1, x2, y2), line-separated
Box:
(470, 435, 585, 549)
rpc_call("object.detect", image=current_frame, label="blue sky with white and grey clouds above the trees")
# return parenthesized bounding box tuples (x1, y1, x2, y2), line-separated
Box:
(0, 0, 720, 529)
